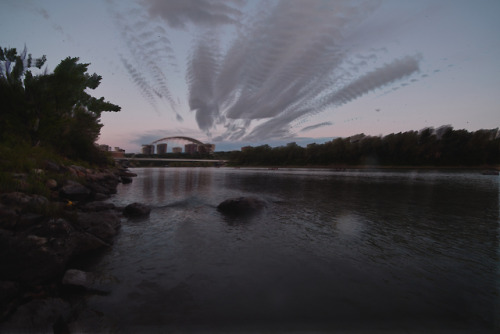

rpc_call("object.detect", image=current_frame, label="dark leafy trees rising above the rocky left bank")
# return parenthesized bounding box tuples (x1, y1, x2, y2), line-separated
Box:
(0, 47, 120, 162)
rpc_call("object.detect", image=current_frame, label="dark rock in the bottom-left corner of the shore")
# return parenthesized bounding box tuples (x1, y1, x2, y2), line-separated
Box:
(0, 298, 71, 333)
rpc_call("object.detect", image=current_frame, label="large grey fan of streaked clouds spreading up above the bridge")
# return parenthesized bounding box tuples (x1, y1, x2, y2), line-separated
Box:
(115, 0, 421, 141)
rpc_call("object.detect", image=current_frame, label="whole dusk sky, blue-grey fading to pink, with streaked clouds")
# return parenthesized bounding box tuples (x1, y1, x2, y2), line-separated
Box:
(0, 0, 500, 152)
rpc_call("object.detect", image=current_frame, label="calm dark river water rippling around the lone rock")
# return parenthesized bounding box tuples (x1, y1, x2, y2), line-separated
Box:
(84, 168, 500, 332)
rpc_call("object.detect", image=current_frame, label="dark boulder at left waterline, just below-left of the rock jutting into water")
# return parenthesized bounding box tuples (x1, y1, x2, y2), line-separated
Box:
(73, 211, 121, 244)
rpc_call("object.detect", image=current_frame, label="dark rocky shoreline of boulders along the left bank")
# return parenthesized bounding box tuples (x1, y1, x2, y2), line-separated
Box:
(0, 161, 150, 333)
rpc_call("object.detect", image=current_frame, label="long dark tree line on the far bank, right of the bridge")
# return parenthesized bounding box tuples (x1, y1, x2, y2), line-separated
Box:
(229, 126, 500, 166)
